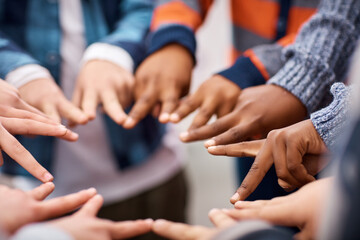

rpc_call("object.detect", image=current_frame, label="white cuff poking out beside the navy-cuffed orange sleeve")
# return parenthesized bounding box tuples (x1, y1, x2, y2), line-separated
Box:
(82, 43, 134, 73)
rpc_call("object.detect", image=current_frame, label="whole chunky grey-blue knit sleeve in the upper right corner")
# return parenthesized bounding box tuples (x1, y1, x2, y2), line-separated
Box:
(268, 0, 360, 113)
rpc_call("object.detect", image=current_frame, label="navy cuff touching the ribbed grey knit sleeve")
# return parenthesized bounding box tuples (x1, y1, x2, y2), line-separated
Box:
(218, 56, 266, 89)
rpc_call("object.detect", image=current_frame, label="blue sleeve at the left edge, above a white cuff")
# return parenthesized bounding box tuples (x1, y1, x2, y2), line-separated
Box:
(0, 32, 39, 79)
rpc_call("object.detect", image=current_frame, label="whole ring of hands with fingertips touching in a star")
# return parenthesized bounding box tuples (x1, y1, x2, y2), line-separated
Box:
(0, 45, 331, 239)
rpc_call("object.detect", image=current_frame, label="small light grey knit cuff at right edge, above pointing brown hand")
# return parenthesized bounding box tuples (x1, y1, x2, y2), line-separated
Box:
(310, 83, 351, 148)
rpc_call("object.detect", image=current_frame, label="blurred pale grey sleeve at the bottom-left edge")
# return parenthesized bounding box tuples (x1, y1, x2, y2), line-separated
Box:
(9, 223, 74, 240)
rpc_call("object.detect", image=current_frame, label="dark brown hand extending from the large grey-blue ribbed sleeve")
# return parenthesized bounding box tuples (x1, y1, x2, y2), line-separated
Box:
(180, 85, 306, 147)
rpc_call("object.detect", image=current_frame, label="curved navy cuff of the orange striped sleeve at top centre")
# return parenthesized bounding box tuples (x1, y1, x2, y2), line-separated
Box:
(147, 24, 196, 63)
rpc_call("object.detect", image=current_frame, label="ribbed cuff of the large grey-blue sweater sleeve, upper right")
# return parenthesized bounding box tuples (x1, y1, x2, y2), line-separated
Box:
(268, 46, 335, 113)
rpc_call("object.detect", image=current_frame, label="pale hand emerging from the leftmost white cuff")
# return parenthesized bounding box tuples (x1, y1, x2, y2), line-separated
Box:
(19, 78, 88, 124)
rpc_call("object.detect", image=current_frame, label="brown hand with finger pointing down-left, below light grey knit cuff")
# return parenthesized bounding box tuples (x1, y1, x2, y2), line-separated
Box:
(228, 120, 327, 203)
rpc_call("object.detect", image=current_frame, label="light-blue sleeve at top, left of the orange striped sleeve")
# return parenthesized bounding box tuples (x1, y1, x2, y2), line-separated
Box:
(94, 0, 153, 66)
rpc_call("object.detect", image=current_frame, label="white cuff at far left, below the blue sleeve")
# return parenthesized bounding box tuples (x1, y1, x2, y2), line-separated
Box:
(5, 64, 52, 88)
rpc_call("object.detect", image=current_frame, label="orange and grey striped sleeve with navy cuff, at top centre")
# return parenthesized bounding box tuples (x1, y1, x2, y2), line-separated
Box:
(147, 0, 213, 60)
